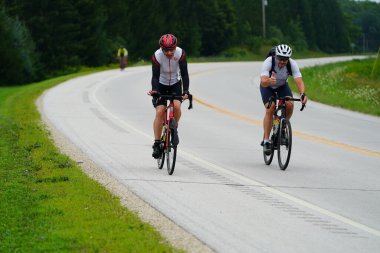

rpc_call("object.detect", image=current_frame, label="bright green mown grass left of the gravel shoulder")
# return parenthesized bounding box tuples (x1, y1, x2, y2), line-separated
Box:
(0, 69, 182, 252)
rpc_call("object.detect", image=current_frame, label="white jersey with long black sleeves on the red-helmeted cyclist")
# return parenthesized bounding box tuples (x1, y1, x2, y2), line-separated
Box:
(152, 47, 189, 91)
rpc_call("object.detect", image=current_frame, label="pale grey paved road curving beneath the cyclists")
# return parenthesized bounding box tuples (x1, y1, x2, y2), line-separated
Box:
(43, 58, 380, 253)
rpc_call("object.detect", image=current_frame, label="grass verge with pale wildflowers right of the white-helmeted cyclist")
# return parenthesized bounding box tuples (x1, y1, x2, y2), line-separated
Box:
(289, 58, 380, 116)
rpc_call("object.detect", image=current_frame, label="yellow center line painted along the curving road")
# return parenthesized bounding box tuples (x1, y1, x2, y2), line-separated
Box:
(193, 96, 380, 158)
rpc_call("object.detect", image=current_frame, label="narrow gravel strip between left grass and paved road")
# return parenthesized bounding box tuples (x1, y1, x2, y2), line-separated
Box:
(36, 91, 215, 253)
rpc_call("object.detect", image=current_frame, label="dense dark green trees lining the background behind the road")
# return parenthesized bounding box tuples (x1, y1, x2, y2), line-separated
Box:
(0, 0, 380, 85)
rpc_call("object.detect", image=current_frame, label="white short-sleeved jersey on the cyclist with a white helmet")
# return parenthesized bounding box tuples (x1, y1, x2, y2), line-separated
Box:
(260, 57, 302, 89)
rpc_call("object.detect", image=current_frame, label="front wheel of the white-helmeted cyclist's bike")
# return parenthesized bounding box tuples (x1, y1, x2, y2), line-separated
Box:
(277, 119, 292, 170)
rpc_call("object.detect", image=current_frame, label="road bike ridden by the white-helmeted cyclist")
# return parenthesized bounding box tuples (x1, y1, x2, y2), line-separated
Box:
(261, 92, 306, 170)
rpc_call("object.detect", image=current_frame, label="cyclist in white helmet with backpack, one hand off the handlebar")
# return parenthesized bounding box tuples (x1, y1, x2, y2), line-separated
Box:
(260, 44, 307, 155)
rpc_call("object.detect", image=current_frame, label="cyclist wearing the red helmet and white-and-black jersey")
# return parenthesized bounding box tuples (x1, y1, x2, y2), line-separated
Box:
(148, 34, 189, 159)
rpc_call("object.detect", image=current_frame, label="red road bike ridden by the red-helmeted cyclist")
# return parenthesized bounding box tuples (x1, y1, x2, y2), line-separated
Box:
(153, 94, 193, 175)
